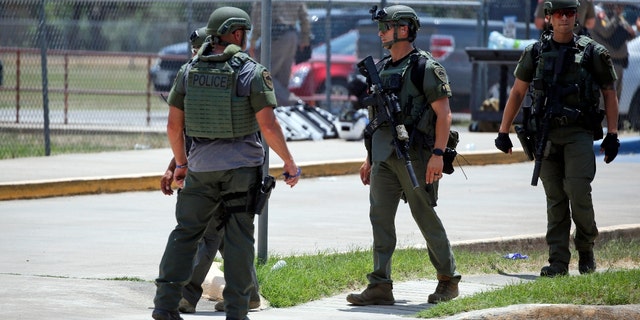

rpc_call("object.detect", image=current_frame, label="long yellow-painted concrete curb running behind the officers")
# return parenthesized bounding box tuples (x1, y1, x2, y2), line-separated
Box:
(0, 150, 527, 201)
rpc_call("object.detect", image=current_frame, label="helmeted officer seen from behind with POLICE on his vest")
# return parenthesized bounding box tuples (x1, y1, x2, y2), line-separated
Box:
(151, 7, 301, 320)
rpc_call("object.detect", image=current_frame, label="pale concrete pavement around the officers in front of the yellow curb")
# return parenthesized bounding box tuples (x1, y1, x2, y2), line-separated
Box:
(0, 131, 640, 320)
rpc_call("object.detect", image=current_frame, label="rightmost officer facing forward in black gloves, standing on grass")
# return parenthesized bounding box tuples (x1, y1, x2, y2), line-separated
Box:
(495, 0, 620, 277)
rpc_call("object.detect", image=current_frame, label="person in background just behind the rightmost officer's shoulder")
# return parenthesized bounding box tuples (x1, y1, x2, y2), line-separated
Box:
(591, 4, 636, 100)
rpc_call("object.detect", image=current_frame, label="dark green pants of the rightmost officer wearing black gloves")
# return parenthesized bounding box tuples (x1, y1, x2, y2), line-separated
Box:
(540, 126, 598, 265)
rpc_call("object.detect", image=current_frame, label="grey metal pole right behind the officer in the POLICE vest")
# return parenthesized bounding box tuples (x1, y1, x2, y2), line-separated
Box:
(258, 0, 271, 264)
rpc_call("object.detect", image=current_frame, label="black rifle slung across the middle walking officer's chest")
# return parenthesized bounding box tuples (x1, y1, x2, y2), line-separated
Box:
(358, 56, 420, 189)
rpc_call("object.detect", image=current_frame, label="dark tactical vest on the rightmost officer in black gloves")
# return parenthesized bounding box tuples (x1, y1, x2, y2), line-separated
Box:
(532, 36, 600, 115)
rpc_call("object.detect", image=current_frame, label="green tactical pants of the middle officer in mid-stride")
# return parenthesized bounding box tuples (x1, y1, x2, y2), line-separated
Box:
(367, 154, 456, 284)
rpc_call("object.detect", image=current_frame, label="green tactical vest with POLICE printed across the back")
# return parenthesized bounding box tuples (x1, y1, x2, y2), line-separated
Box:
(184, 52, 259, 139)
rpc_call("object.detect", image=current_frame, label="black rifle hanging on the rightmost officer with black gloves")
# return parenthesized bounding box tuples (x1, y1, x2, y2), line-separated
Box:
(531, 46, 579, 186)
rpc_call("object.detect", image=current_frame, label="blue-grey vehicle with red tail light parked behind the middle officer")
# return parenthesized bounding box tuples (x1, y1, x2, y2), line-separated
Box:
(357, 17, 540, 113)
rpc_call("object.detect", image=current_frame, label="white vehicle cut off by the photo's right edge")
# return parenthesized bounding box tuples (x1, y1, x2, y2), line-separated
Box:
(619, 36, 640, 130)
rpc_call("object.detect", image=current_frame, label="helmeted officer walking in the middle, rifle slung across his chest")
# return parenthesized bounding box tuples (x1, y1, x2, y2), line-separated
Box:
(347, 5, 462, 306)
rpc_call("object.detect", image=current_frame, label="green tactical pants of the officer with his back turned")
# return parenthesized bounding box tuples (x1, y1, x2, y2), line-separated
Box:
(154, 167, 259, 319)
